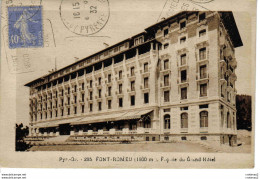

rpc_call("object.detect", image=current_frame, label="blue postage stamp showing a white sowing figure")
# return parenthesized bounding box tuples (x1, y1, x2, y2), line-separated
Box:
(8, 6, 43, 49)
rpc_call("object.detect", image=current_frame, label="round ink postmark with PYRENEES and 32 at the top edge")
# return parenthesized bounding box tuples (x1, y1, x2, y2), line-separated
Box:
(60, 0, 110, 36)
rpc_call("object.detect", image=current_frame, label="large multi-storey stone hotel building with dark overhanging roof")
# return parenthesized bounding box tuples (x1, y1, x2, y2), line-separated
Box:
(25, 12, 243, 144)
